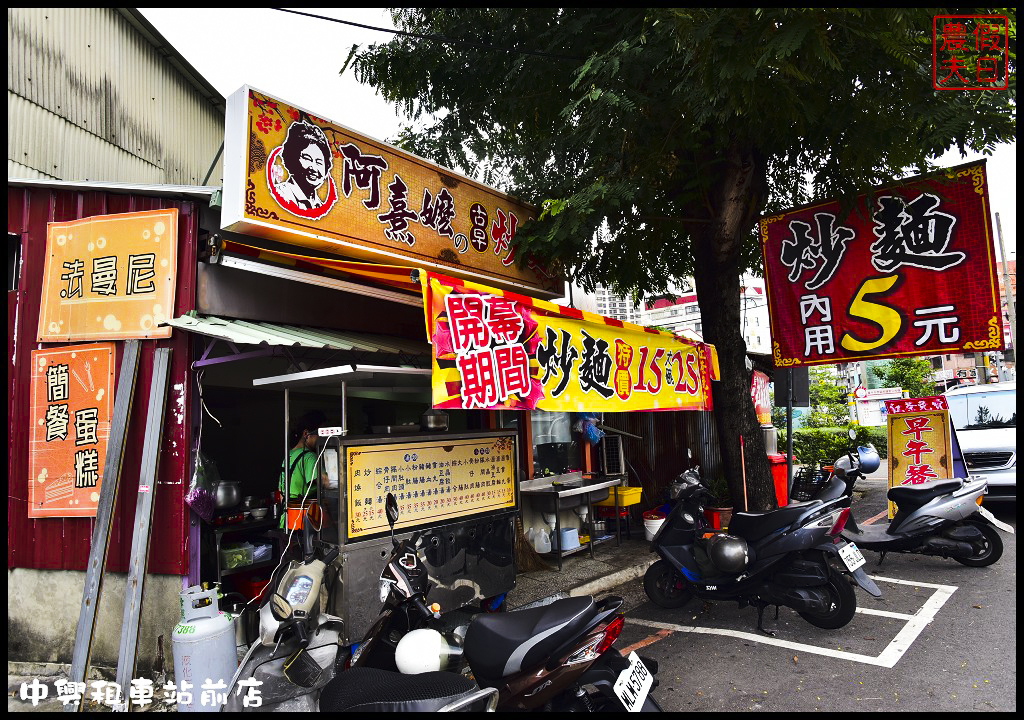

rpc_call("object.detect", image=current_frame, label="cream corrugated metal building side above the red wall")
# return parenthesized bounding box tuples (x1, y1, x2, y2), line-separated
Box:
(7, 7, 224, 184)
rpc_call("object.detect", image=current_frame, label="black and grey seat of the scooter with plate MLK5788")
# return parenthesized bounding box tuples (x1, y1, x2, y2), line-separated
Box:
(464, 596, 598, 680)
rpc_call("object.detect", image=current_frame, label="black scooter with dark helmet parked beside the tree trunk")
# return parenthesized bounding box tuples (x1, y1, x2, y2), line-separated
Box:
(644, 469, 882, 634)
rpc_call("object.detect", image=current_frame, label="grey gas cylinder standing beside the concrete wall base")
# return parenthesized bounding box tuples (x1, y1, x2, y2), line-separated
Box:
(171, 585, 239, 713)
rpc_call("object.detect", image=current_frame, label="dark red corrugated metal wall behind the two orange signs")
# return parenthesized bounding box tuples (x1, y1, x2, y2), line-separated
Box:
(7, 186, 199, 575)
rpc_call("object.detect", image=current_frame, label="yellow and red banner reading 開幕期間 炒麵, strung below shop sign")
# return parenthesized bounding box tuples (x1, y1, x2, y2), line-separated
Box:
(420, 272, 718, 412)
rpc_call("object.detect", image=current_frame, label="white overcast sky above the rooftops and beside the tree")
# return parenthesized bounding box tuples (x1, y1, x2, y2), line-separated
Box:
(139, 7, 1017, 259)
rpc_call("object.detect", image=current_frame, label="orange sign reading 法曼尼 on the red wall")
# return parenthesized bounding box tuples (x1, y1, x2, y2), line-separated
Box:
(36, 208, 178, 342)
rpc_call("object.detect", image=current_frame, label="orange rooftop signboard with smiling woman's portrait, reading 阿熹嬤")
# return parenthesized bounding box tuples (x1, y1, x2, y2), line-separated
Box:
(221, 86, 564, 297)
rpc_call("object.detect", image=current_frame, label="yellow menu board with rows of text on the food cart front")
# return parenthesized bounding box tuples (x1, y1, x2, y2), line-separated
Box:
(345, 434, 516, 539)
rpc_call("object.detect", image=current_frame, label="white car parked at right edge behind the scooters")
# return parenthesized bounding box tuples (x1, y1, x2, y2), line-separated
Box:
(944, 382, 1017, 500)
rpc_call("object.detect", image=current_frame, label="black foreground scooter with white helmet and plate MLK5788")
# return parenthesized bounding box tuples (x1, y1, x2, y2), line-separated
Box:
(356, 494, 660, 712)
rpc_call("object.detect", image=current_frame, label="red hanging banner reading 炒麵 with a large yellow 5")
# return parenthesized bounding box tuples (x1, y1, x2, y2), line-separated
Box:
(760, 163, 1002, 367)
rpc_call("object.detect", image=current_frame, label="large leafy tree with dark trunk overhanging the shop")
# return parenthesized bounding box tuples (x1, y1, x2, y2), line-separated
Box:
(352, 6, 1016, 509)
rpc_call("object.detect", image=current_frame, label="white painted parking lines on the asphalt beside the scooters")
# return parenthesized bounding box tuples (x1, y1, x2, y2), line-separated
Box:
(629, 576, 957, 668)
